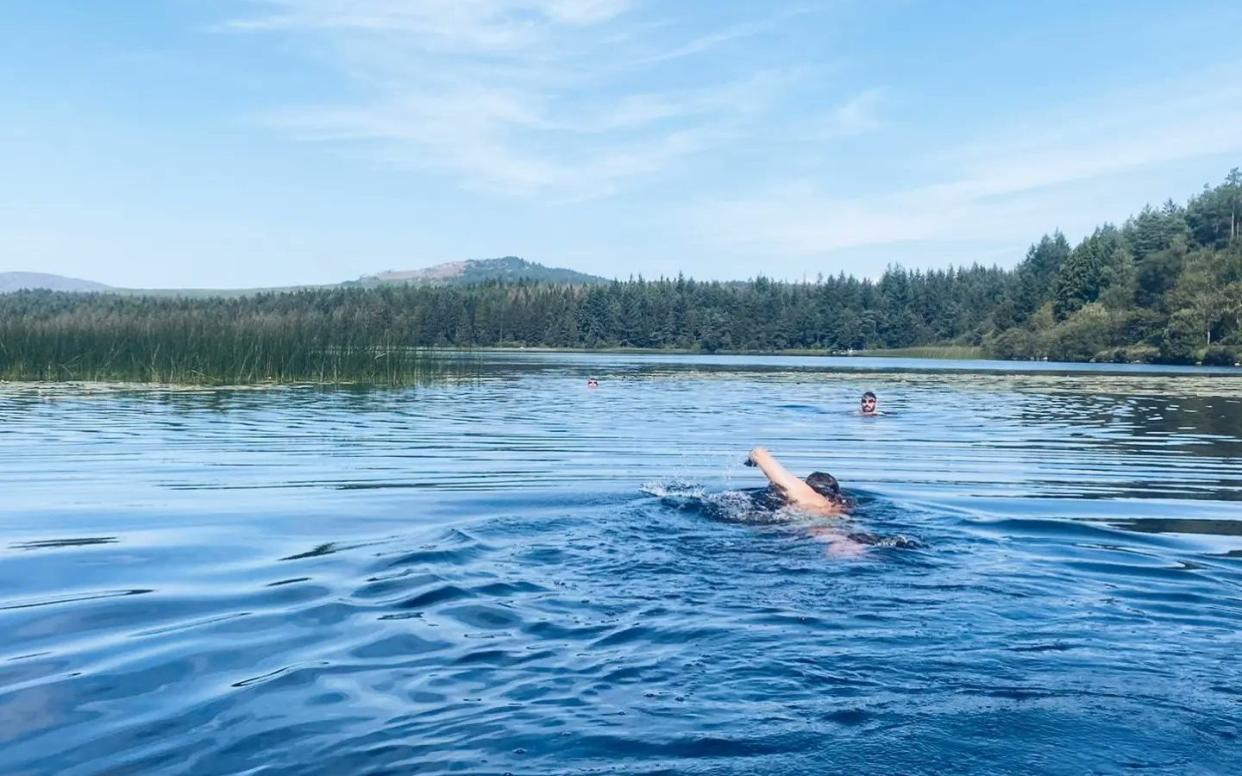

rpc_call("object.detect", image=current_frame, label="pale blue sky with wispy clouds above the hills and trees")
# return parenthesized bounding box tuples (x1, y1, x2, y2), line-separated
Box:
(0, 0, 1242, 287)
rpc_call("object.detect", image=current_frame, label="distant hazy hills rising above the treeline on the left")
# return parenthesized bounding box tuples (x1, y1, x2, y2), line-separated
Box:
(0, 256, 609, 297)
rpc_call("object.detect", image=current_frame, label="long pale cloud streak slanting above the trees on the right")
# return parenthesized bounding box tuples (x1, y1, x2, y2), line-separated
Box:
(688, 65, 1242, 261)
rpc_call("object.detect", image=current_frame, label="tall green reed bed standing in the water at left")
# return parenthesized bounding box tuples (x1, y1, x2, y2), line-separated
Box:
(0, 292, 465, 385)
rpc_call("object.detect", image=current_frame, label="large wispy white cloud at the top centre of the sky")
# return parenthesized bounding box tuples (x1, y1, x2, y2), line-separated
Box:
(229, 0, 844, 199)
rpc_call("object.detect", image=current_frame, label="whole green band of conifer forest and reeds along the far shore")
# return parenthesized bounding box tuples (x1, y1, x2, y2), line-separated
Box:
(0, 169, 1242, 382)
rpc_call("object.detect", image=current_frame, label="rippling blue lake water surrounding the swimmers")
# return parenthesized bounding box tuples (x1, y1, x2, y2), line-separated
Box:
(0, 355, 1242, 775)
